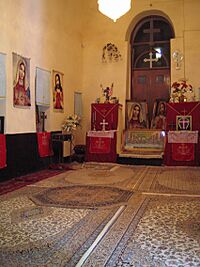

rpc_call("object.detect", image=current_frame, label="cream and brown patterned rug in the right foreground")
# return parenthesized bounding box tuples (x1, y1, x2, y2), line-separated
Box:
(82, 197, 200, 267)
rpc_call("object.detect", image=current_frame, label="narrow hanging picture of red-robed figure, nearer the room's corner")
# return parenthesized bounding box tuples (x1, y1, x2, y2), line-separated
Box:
(53, 70, 64, 112)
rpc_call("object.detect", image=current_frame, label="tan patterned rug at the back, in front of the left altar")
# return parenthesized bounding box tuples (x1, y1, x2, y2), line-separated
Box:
(32, 165, 146, 191)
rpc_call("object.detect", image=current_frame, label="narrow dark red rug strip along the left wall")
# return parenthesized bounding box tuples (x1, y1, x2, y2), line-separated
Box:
(0, 170, 66, 195)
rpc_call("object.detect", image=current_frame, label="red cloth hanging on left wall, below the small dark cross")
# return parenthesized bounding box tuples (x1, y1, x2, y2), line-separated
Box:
(37, 132, 53, 158)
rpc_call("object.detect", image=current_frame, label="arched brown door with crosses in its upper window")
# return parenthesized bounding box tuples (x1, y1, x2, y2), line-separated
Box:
(131, 16, 174, 120)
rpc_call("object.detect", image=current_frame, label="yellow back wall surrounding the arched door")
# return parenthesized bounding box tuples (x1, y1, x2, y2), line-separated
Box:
(79, 0, 200, 144)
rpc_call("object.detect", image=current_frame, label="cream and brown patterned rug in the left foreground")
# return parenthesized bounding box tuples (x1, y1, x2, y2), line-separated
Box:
(0, 195, 117, 267)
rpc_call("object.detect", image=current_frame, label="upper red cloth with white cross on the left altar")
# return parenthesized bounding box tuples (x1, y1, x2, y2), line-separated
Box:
(91, 103, 120, 131)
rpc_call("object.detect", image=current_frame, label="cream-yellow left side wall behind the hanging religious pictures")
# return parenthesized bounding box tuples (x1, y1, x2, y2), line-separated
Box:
(0, 0, 82, 133)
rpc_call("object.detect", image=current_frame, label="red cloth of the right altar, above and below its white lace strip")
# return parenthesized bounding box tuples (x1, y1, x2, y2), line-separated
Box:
(164, 102, 200, 166)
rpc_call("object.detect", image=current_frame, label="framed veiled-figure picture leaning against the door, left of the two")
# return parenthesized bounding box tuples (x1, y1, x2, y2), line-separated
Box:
(127, 101, 149, 130)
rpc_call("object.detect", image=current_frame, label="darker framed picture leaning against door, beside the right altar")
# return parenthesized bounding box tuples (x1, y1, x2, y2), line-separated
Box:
(151, 100, 166, 130)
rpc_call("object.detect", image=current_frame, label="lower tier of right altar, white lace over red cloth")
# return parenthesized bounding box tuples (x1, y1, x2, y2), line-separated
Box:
(165, 131, 198, 166)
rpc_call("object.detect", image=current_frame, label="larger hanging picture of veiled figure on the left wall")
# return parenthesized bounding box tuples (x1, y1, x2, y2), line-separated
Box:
(13, 53, 31, 107)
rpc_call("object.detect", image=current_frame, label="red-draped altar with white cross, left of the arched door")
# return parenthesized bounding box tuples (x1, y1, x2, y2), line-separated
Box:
(86, 103, 122, 162)
